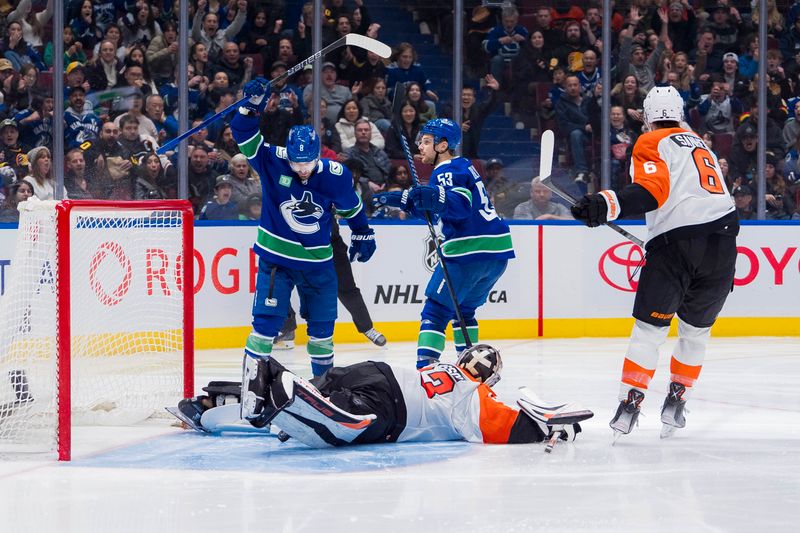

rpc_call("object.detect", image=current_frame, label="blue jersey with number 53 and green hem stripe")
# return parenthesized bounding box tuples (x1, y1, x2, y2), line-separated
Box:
(430, 157, 514, 263)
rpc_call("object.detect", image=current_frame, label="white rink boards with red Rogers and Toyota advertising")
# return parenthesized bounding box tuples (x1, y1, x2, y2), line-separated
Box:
(0, 222, 800, 336)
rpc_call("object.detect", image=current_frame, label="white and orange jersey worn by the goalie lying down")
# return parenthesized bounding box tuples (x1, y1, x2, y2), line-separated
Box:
(392, 363, 519, 444)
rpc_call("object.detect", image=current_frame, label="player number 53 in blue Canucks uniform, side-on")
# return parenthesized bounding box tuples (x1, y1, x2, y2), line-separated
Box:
(374, 119, 514, 368)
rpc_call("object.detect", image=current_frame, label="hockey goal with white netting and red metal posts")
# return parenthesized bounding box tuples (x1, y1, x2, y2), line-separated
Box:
(0, 198, 194, 460)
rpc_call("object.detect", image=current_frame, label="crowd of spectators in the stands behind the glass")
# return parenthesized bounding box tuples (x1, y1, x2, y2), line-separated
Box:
(0, 0, 800, 220)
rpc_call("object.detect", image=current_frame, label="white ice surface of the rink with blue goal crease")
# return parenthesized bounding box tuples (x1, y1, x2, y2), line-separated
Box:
(0, 338, 800, 533)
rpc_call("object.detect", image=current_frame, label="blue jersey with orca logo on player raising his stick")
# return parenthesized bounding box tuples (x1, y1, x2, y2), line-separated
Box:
(231, 113, 369, 270)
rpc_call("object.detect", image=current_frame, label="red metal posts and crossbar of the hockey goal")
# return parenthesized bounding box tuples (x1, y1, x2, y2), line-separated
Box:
(55, 200, 194, 461)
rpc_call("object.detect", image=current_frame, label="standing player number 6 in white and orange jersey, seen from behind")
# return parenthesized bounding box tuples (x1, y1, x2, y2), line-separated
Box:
(572, 87, 739, 437)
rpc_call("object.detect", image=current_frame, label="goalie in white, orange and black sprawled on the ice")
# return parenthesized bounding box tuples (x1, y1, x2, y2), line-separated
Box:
(170, 344, 592, 448)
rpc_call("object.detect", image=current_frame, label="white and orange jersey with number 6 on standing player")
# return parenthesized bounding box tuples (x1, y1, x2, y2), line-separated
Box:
(631, 128, 735, 239)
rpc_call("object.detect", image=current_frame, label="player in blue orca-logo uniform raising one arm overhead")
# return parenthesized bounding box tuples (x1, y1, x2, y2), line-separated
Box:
(231, 78, 375, 378)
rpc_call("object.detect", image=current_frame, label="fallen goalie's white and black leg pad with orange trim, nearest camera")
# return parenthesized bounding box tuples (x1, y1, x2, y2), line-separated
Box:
(273, 371, 377, 448)
